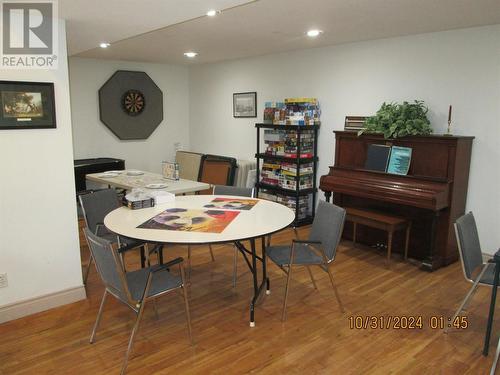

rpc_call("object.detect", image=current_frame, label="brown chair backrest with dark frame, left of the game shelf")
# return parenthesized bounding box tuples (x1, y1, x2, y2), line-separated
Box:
(198, 155, 237, 194)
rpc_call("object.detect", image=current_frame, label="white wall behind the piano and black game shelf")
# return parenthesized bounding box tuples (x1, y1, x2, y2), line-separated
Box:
(190, 25, 500, 253)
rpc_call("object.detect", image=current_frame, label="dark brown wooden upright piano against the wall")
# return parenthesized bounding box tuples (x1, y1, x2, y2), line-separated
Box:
(319, 131, 474, 271)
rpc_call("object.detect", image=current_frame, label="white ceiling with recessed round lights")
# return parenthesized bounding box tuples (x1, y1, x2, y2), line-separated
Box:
(67, 0, 500, 64)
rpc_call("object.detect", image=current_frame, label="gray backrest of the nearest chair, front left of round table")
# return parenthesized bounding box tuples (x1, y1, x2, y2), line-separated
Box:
(85, 228, 131, 301)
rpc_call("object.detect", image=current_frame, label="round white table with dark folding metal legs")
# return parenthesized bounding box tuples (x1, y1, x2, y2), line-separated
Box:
(104, 195, 295, 327)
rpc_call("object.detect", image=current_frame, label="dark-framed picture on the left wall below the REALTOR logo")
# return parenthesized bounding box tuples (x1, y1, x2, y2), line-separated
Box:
(0, 81, 56, 130)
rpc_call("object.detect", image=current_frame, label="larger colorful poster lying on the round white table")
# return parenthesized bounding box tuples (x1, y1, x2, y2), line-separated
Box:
(137, 208, 239, 233)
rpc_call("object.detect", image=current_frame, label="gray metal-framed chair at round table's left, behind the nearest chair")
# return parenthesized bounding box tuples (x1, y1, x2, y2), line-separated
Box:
(78, 189, 145, 284)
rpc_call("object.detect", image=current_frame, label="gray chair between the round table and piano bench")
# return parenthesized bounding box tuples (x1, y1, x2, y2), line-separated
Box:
(267, 201, 346, 321)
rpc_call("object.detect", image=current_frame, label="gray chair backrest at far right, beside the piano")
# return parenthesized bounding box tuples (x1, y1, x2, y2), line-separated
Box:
(455, 212, 483, 280)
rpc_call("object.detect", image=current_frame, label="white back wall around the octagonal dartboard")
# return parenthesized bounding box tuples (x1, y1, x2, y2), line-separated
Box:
(69, 57, 189, 172)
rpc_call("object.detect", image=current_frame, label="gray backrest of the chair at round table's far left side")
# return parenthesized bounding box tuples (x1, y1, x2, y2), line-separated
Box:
(78, 189, 120, 234)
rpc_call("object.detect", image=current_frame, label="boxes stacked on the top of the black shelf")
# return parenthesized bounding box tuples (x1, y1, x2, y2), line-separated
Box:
(264, 98, 321, 125)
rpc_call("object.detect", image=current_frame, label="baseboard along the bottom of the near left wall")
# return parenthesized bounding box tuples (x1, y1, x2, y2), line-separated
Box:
(0, 285, 87, 324)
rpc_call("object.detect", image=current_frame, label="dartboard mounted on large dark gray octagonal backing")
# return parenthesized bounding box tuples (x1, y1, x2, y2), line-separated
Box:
(99, 70, 163, 140)
